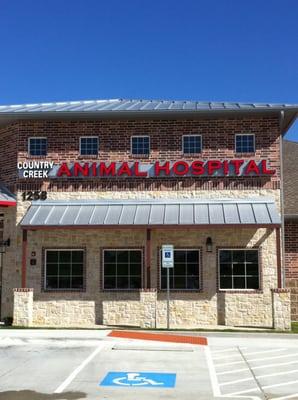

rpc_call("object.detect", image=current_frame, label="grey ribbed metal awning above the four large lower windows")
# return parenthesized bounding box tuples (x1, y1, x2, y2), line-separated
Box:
(21, 198, 280, 228)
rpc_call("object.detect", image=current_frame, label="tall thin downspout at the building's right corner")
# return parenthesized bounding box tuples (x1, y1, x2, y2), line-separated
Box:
(279, 111, 286, 288)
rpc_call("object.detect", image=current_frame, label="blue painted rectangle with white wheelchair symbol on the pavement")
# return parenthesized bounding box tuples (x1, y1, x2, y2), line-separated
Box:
(99, 372, 176, 388)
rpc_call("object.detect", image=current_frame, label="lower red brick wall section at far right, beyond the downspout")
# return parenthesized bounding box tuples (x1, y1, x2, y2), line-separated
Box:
(285, 220, 298, 321)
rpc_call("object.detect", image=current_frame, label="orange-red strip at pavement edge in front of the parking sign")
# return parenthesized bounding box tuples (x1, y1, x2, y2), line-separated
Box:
(107, 331, 208, 346)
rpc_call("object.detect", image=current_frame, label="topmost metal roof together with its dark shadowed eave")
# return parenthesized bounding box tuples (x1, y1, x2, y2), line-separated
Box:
(0, 99, 298, 133)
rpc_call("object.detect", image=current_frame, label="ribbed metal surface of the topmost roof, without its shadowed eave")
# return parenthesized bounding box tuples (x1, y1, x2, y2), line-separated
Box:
(0, 99, 298, 114)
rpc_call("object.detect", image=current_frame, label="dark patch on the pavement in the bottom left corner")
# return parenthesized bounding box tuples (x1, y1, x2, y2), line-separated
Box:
(0, 390, 86, 400)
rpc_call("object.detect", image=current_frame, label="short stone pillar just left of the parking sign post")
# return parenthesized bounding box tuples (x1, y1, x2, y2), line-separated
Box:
(140, 289, 157, 328)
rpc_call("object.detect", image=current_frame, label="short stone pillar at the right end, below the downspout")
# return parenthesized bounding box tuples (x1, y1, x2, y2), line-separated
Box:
(271, 289, 291, 331)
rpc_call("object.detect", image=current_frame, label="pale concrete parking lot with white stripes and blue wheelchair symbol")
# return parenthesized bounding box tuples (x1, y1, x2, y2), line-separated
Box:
(0, 329, 298, 400)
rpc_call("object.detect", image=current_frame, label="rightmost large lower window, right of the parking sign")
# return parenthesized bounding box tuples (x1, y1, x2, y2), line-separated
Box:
(219, 249, 260, 289)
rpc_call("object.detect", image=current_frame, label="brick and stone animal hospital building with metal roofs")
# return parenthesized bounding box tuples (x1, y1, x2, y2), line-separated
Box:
(0, 100, 298, 329)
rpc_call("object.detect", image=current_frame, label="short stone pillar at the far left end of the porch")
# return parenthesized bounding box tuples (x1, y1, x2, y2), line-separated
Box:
(13, 288, 33, 327)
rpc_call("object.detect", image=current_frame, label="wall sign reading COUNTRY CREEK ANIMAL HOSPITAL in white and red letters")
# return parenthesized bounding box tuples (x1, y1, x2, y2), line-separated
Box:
(17, 159, 276, 179)
